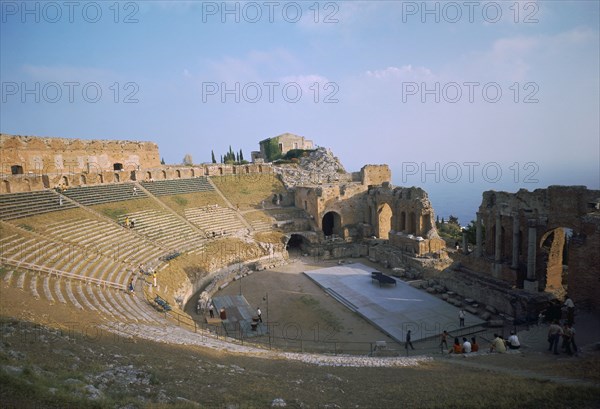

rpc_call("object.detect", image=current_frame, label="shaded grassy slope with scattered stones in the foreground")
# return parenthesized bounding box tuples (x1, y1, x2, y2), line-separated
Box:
(0, 317, 600, 409)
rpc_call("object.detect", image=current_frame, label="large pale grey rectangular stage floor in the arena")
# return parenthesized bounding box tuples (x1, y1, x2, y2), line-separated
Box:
(304, 263, 485, 346)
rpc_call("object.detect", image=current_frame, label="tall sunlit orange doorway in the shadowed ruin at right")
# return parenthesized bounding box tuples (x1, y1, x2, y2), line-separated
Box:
(538, 227, 573, 297)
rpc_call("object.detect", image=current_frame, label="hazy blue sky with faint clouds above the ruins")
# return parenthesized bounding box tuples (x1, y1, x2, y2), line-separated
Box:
(0, 1, 600, 224)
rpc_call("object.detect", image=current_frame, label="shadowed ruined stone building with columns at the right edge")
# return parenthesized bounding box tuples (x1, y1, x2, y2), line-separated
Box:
(472, 186, 600, 306)
